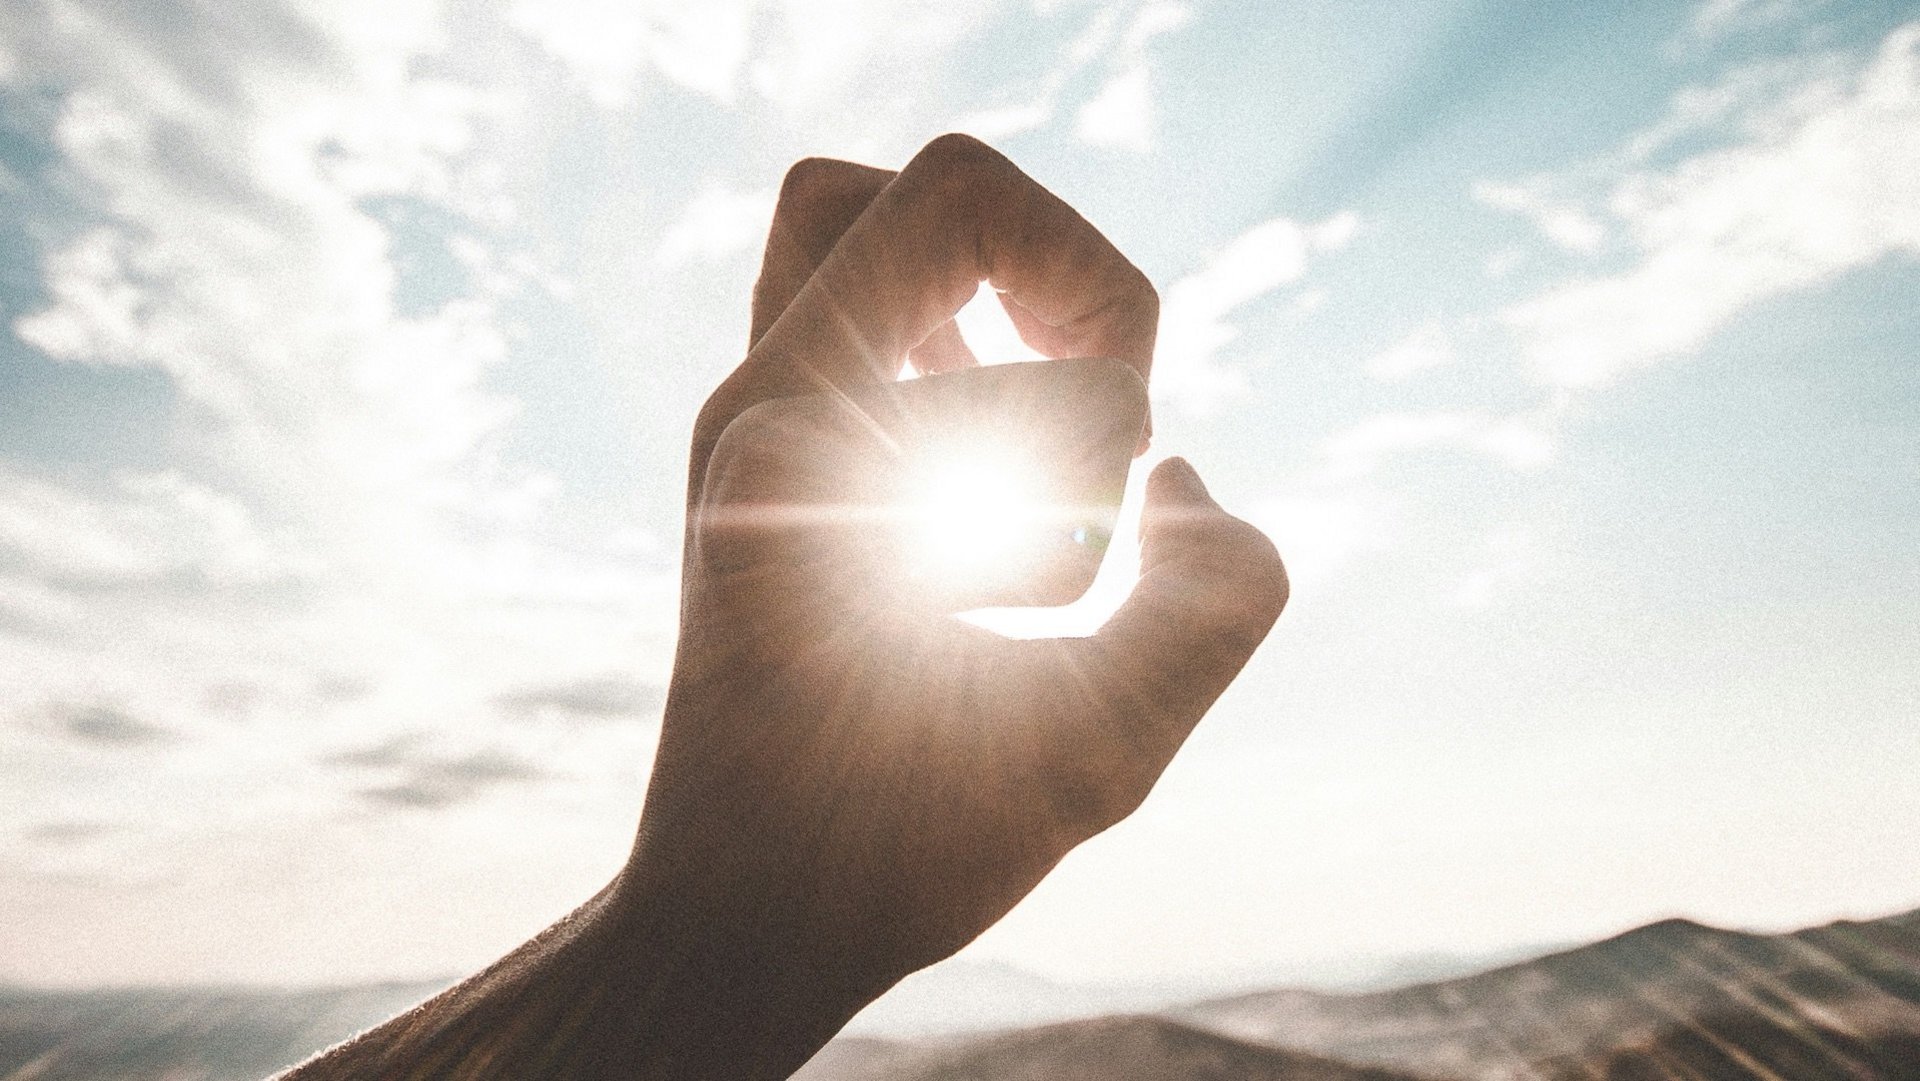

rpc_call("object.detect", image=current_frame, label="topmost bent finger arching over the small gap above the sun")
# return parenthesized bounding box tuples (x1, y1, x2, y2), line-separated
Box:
(747, 134, 1160, 414)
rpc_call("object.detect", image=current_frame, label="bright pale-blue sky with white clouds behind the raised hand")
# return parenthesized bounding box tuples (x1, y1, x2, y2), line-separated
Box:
(0, 0, 1920, 987)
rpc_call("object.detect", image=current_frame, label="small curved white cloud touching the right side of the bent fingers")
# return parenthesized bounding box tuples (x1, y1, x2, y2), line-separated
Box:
(1152, 213, 1357, 413)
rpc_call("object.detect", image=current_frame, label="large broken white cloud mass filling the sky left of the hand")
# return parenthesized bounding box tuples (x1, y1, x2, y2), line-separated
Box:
(0, 2, 674, 977)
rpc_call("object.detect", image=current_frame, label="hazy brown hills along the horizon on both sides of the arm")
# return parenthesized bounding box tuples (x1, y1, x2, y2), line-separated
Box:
(0, 910, 1920, 1081)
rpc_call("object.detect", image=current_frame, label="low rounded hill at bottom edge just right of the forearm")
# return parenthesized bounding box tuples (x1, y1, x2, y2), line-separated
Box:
(793, 1016, 1417, 1081)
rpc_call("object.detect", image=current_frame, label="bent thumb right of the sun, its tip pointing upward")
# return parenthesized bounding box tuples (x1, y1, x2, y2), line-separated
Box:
(1058, 459, 1288, 810)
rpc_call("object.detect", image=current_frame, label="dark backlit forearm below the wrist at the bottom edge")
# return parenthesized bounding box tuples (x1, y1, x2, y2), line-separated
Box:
(280, 879, 879, 1081)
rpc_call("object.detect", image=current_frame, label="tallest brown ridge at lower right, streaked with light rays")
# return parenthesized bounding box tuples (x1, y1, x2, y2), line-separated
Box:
(1171, 912, 1920, 1081)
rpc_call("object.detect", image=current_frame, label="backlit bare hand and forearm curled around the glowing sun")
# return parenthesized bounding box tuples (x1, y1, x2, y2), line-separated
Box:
(284, 136, 1286, 1081)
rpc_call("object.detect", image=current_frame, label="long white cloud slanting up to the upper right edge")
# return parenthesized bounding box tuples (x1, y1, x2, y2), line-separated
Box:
(1505, 25, 1920, 386)
